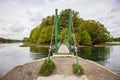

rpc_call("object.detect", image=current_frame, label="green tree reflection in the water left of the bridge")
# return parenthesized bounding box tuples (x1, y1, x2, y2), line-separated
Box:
(30, 47, 48, 59)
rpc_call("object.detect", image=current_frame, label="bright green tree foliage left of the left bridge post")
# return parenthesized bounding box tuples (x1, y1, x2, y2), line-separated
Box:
(30, 16, 54, 44)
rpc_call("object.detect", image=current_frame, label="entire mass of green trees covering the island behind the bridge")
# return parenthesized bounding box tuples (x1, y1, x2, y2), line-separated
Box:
(30, 9, 110, 44)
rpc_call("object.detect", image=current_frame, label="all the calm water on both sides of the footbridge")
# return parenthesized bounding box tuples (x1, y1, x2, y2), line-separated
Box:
(0, 43, 120, 75)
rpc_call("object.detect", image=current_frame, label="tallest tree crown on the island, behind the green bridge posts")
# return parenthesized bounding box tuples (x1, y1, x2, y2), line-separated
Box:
(58, 9, 83, 31)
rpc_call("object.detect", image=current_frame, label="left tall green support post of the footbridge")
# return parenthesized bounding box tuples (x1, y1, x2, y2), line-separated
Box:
(55, 9, 58, 53)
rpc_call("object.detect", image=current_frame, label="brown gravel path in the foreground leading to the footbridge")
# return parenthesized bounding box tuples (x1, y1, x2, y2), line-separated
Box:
(0, 57, 120, 80)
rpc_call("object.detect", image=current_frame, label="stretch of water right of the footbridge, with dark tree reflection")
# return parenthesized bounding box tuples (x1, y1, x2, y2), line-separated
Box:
(78, 46, 120, 74)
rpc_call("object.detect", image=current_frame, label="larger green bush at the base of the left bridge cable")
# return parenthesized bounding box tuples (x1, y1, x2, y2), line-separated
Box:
(38, 59, 55, 76)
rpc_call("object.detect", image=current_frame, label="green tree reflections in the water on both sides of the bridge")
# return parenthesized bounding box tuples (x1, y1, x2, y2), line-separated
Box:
(30, 47, 110, 61)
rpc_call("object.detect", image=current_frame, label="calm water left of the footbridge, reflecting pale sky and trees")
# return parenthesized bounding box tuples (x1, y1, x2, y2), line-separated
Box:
(0, 43, 48, 76)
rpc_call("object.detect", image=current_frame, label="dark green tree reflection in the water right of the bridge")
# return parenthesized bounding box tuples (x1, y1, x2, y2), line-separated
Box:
(78, 47, 110, 61)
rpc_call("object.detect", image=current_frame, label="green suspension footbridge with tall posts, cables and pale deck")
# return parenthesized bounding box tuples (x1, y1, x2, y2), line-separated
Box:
(48, 9, 80, 74)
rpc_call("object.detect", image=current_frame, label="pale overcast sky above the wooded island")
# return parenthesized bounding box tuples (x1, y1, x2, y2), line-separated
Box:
(0, 0, 120, 39)
